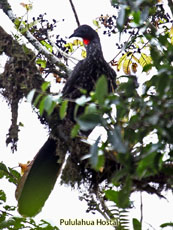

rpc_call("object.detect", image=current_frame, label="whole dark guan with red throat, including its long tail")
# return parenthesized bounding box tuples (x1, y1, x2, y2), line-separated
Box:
(16, 25, 116, 216)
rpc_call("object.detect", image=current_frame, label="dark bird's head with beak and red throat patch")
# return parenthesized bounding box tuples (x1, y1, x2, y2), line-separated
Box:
(69, 25, 98, 45)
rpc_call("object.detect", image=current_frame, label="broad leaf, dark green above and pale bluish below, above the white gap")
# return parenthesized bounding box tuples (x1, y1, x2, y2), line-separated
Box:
(76, 113, 101, 131)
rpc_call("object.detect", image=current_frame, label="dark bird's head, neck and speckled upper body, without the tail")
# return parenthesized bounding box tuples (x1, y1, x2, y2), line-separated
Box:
(63, 25, 116, 99)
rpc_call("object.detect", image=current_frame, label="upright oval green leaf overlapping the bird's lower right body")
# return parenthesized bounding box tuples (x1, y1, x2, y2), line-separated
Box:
(96, 75, 108, 105)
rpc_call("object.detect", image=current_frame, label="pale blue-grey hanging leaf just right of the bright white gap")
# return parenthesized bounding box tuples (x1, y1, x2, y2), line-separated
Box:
(108, 127, 127, 153)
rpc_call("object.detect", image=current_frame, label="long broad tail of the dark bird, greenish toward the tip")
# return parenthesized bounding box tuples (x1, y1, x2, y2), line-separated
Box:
(16, 138, 63, 216)
